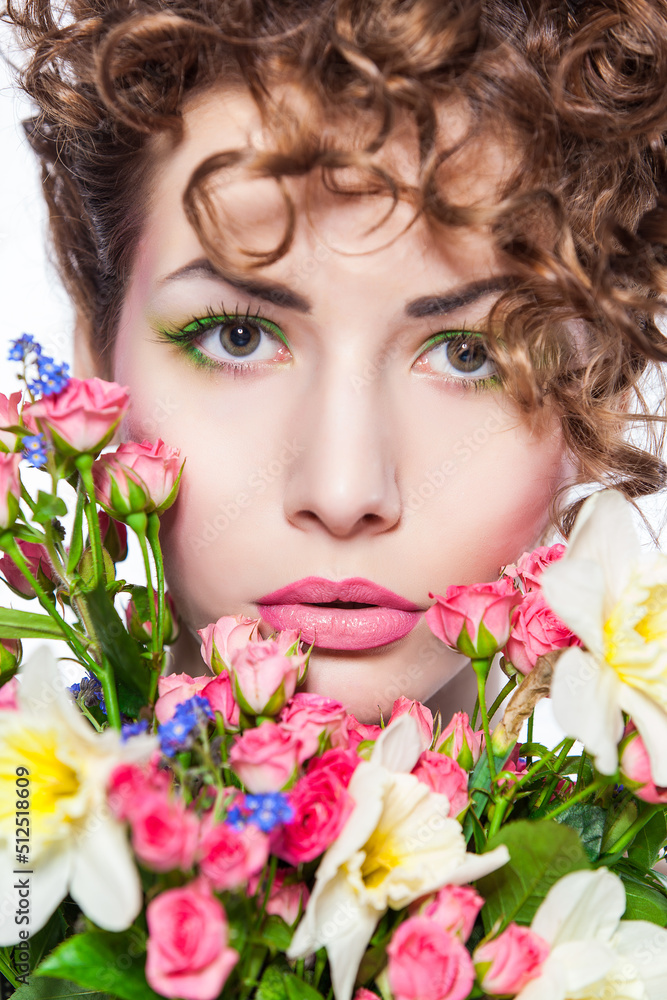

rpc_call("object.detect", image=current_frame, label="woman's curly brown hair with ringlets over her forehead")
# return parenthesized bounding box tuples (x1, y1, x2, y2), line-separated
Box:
(5, 0, 667, 534)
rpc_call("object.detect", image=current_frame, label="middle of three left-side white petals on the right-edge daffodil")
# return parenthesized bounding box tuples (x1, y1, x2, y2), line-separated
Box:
(540, 556, 605, 656)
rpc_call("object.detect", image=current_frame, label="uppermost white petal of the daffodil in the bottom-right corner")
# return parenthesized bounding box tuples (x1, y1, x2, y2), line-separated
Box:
(530, 868, 625, 947)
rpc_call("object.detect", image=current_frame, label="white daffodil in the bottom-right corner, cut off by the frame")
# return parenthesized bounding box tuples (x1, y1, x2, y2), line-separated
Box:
(516, 868, 667, 1000)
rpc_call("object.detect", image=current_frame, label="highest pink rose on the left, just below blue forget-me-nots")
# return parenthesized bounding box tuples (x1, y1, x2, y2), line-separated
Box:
(23, 378, 130, 455)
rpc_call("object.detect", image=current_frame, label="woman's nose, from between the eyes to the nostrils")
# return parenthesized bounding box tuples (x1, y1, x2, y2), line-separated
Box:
(284, 360, 401, 538)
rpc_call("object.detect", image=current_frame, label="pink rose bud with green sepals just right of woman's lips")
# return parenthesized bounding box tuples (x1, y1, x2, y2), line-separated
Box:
(424, 578, 522, 660)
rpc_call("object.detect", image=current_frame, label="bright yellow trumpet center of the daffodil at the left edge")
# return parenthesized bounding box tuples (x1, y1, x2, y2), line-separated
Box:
(0, 719, 85, 855)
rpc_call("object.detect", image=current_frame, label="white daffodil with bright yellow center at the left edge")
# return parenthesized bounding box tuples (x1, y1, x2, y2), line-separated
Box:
(0, 647, 157, 946)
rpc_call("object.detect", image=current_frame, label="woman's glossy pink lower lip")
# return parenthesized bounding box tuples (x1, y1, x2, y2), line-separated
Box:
(258, 604, 423, 649)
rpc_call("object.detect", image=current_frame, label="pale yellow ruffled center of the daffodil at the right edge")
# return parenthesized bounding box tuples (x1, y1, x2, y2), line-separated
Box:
(603, 578, 667, 711)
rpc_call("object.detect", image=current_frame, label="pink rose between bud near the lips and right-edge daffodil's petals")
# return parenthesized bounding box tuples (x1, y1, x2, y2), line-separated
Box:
(503, 590, 581, 674)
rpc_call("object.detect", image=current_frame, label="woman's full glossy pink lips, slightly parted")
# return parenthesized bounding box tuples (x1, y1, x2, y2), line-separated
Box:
(257, 576, 423, 650)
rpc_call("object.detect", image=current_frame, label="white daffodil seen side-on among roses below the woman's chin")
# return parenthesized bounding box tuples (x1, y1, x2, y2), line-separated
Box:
(287, 715, 509, 1000)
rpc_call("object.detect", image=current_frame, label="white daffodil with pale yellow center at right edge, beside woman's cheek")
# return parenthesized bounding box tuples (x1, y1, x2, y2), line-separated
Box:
(541, 490, 667, 785)
